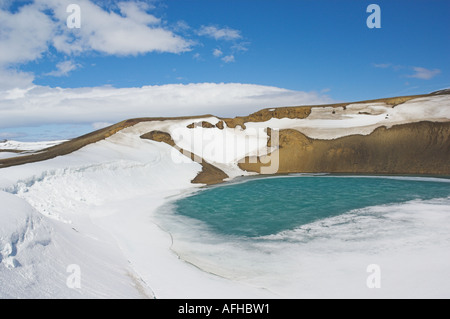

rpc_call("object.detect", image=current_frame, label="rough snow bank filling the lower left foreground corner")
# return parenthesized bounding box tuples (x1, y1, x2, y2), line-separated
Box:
(0, 192, 144, 298)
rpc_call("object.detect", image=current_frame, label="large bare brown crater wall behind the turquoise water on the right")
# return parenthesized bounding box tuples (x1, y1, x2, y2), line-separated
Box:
(239, 122, 450, 175)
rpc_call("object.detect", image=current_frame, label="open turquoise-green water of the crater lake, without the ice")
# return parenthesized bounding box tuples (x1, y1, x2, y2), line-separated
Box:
(174, 176, 450, 237)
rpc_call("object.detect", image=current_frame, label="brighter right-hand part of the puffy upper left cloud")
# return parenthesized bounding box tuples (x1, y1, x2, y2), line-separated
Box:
(45, 0, 191, 55)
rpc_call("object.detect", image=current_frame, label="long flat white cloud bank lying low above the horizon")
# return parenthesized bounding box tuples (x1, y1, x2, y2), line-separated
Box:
(0, 83, 333, 128)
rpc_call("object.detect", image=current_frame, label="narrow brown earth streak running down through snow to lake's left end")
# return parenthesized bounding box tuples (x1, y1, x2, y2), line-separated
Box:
(141, 131, 228, 185)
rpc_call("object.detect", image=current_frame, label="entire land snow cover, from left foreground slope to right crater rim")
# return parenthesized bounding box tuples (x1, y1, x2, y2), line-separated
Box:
(0, 95, 450, 298)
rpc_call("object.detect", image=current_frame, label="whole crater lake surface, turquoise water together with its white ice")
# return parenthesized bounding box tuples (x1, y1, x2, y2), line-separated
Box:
(158, 175, 450, 297)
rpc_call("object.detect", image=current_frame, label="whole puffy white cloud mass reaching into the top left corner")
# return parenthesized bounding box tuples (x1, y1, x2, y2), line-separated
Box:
(0, 0, 192, 68)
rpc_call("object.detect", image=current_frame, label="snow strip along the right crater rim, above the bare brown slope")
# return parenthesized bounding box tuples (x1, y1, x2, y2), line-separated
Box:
(245, 95, 450, 139)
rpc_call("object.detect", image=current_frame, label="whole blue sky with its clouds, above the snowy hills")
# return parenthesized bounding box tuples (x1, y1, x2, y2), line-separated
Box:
(0, 0, 450, 141)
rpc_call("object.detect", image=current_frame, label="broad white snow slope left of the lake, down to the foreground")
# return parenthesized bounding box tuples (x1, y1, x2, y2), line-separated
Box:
(0, 122, 272, 298)
